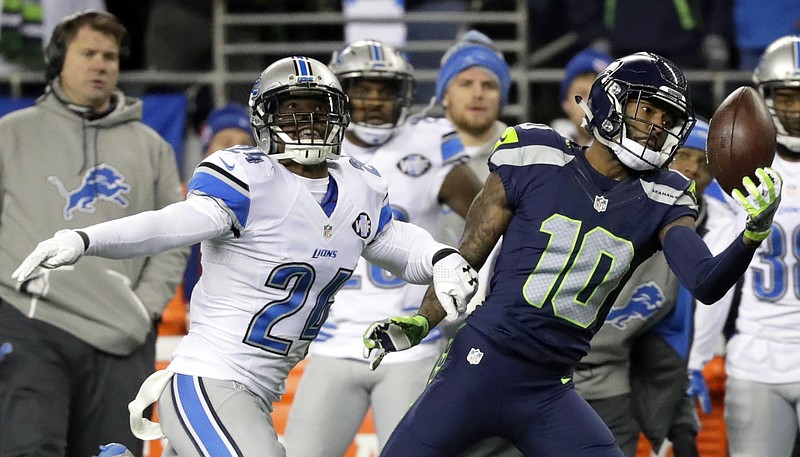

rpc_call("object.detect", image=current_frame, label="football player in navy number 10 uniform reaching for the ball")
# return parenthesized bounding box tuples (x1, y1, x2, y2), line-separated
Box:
(364, 53, 781, 457)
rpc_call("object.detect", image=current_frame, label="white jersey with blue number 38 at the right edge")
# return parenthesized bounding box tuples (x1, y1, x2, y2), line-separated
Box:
(690, 155, 800, 384)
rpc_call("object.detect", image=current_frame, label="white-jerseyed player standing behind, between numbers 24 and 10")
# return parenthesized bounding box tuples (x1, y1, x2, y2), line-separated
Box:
(284, 40, 480, 457)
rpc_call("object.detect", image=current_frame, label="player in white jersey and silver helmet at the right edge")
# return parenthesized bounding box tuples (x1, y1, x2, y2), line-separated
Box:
(690, 36, 800, 457)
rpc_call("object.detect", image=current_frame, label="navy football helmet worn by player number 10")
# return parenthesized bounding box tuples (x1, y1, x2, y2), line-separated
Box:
(579, 52, 695, 171)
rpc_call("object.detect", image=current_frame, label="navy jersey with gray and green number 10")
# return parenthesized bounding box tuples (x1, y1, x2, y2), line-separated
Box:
(467, 124, 697, 374)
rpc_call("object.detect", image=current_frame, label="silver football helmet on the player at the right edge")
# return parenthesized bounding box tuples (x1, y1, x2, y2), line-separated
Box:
(753, 35, 800, 153)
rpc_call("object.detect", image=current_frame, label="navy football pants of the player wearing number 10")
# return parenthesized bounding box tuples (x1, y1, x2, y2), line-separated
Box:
(381, 325, 622, 457)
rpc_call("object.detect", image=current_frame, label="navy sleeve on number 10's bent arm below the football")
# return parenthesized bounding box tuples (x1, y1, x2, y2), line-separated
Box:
(663, 226, 757, 305)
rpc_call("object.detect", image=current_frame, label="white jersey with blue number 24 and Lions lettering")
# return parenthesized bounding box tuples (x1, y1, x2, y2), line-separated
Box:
(168, 147, 391, 403)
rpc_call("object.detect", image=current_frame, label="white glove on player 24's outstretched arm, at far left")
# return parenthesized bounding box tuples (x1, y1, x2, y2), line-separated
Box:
(11, 230, 86, 282)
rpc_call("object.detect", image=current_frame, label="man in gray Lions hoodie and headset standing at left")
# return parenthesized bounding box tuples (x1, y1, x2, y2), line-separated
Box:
(0, 11, 188, 457)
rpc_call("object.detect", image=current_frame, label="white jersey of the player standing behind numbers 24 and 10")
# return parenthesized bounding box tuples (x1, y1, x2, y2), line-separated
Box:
(310, 118, 466, 364)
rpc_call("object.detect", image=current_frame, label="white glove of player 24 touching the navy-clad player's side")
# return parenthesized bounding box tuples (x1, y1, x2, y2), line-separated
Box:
(433, 249, 478, 320)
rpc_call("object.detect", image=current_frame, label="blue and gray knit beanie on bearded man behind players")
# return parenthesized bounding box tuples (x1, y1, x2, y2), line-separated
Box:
(436, 30, 511, 108)
